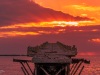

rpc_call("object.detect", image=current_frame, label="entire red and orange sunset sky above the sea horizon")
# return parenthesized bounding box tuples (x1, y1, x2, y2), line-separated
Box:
(0, 0, 100, 55)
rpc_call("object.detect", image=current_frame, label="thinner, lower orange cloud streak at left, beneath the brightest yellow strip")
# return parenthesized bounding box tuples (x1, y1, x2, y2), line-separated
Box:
(0, 29, 64, 38)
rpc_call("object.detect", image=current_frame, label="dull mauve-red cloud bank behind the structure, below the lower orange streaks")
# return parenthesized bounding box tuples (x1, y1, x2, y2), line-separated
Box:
(0, 29, 100, 54)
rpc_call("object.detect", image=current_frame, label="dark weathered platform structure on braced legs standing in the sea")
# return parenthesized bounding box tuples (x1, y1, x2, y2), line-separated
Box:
(13, 42, 90, 75)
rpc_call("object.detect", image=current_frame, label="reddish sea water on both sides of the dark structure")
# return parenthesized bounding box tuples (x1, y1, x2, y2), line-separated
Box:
(0, 56, 100, 75)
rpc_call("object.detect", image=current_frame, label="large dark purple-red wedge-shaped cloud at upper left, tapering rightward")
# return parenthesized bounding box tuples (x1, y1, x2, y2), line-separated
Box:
(0, 0, 90, 26)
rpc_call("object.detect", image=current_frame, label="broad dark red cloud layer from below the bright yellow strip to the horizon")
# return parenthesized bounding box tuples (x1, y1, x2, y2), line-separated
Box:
(0, 26, 100, 54)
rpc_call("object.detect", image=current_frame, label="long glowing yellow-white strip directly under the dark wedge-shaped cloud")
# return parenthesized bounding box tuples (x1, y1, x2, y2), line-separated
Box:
(0, 21, 94, 29)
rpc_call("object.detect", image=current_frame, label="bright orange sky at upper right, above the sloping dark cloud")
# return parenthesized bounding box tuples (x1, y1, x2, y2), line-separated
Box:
(34, 0, 100, 24)
